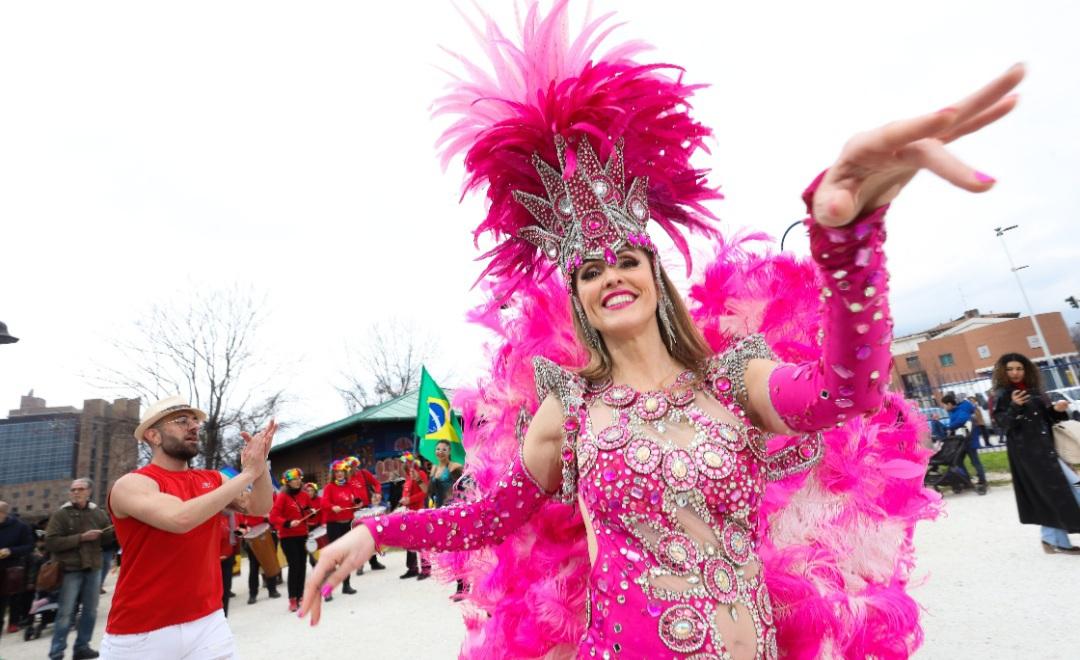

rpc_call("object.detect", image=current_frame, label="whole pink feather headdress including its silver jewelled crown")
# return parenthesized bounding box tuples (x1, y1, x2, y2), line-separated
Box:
(433, 0, 723, 289)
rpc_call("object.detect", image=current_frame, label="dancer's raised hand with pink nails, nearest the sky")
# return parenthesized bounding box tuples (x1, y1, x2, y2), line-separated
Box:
(813, 64, 1025, 227)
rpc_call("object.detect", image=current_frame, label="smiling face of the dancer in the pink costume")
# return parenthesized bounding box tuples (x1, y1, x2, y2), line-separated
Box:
(573, 250, 657, 338)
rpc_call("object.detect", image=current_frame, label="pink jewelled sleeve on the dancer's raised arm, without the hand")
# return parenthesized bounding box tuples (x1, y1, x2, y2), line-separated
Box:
(769, 173, 892, 431)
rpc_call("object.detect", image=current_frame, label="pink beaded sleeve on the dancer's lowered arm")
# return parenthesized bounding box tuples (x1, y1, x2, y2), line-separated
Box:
(363, 453, 549, 552)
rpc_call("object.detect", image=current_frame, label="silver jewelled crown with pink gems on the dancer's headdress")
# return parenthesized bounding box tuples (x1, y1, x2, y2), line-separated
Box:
(514, 135, 656, 283)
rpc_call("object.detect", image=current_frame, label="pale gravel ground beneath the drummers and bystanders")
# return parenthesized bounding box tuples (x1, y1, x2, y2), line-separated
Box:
(0, 485, 1080, 660)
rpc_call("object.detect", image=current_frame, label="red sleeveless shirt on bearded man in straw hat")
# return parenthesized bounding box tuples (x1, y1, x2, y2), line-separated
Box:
(105, 464, 221, 635)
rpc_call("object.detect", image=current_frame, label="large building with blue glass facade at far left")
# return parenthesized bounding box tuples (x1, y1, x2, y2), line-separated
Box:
(0, 392, 139, 521)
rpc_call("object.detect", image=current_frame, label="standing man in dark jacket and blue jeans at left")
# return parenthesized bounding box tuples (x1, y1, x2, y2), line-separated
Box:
(45, 479, 116, 660)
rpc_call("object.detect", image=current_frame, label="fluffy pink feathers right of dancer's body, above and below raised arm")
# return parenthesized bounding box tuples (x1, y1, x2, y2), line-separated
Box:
(690, 234, 941, 659)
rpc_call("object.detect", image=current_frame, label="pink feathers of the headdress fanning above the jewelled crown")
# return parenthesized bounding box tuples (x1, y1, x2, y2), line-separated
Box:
(433, 0, 723, 280)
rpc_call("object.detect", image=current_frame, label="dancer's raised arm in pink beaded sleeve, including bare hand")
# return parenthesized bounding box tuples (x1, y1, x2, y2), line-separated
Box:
(744, 65, 1024, 433)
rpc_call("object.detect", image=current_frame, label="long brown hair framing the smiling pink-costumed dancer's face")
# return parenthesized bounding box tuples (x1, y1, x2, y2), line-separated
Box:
(570, 253, 713, 382)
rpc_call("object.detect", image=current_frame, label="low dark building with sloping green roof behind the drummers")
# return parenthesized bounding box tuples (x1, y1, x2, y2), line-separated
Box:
(270, 392, 429, 486)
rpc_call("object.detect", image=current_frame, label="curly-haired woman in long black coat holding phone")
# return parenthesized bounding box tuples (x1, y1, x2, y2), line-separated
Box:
(994, 353, 1080, 555)
